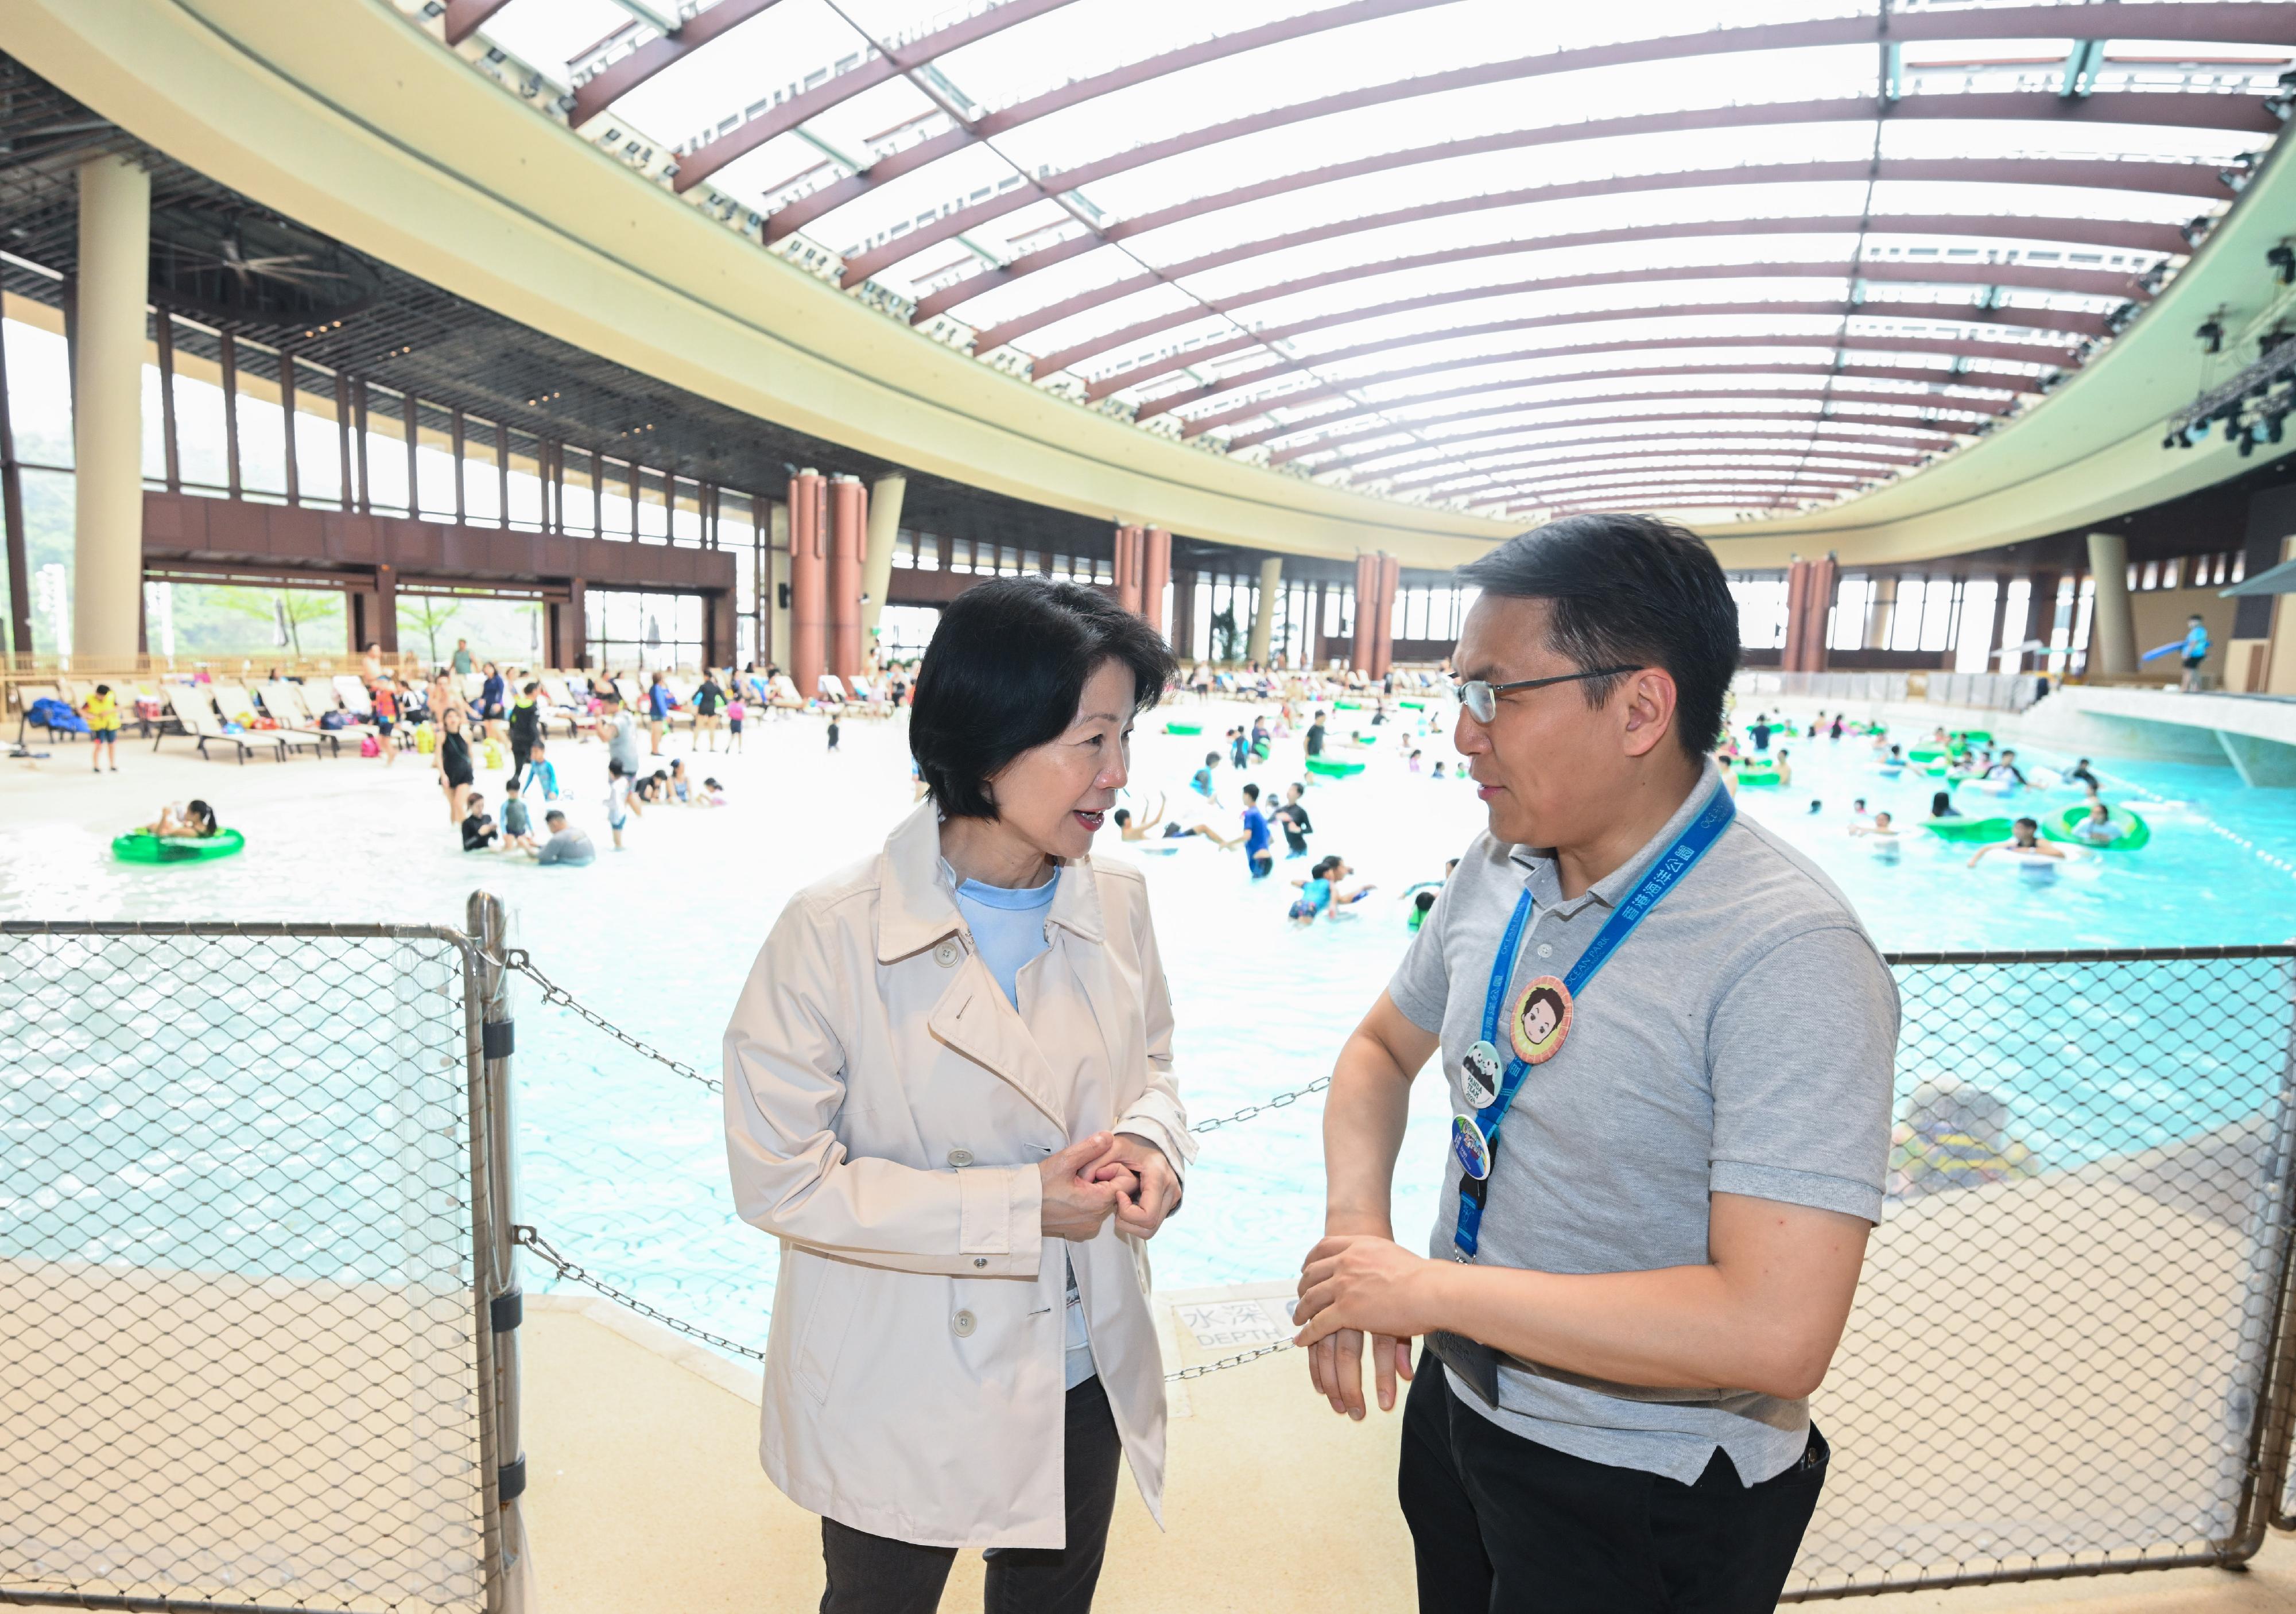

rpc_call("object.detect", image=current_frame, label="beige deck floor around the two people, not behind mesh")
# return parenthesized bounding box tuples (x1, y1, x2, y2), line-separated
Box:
(523, 1286, 2296, 1614)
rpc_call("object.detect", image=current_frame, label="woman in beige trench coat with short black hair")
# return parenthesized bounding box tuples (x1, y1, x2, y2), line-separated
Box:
(726, 579, 1194, 1614)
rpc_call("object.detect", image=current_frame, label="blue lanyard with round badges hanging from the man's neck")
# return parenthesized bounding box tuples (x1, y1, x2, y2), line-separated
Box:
(1428, 787, 1738, 1405)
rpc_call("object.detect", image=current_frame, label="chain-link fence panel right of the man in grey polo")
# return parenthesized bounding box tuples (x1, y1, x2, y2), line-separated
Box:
(1789, 948, 2296, 1598)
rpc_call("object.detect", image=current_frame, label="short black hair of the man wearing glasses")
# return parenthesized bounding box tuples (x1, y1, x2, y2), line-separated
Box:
(1458, 514, 1738, 755)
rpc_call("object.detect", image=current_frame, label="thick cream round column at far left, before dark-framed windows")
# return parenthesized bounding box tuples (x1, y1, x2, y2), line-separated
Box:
(71, 156, 152, 664)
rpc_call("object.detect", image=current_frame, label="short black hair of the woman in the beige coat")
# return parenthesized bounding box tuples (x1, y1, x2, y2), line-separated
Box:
(909, 576, 1178, 817)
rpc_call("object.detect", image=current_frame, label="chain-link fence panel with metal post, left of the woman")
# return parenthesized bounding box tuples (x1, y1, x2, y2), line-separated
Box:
(0, 900, 517, 1614)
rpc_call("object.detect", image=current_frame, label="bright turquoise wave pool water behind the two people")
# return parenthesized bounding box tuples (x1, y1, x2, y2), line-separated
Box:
(0, 700, 2296, 1341)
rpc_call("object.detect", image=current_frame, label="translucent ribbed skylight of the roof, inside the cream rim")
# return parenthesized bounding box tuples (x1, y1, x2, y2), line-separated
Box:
(475, 0, 2296, 517)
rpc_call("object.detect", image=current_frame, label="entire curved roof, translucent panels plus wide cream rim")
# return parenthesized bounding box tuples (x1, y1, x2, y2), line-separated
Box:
(11, 0, 2296, 567)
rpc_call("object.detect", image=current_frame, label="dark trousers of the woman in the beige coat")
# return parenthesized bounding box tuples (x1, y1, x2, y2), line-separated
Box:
(822, 1378, 1123, 1614)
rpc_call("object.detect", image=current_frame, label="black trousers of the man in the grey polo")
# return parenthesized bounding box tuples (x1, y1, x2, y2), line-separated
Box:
(1398, 1352, 1828, 1614)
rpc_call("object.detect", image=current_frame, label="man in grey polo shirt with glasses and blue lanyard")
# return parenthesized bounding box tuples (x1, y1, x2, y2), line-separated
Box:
(1300, 517, 1896, 1614)
